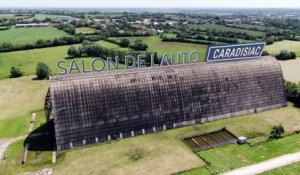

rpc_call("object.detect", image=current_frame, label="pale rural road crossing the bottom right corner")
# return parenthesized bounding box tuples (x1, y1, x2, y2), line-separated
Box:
(222, 151, 300, 175)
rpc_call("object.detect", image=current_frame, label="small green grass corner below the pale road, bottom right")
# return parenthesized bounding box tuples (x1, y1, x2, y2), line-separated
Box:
(260, 162, 300, 175)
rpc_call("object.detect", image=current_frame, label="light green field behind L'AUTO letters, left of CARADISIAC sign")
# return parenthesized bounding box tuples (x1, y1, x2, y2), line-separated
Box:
(114, 34, 207, 60)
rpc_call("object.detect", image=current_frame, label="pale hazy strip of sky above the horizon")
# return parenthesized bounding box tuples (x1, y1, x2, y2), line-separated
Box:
(0, 0, 300, 8)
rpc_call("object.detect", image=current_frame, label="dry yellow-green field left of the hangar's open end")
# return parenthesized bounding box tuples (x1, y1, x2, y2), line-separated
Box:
(0, 76, 49, 138)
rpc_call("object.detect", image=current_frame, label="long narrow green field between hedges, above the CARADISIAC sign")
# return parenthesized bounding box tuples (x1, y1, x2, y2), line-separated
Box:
(189, 24, 265, 36)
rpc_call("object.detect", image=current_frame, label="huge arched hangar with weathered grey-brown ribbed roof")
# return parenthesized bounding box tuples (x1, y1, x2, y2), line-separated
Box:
(45, 57, 287, 151)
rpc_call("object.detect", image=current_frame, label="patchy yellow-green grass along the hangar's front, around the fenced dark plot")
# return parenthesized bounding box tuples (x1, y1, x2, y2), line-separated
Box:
(0, 104, 300, 174)
